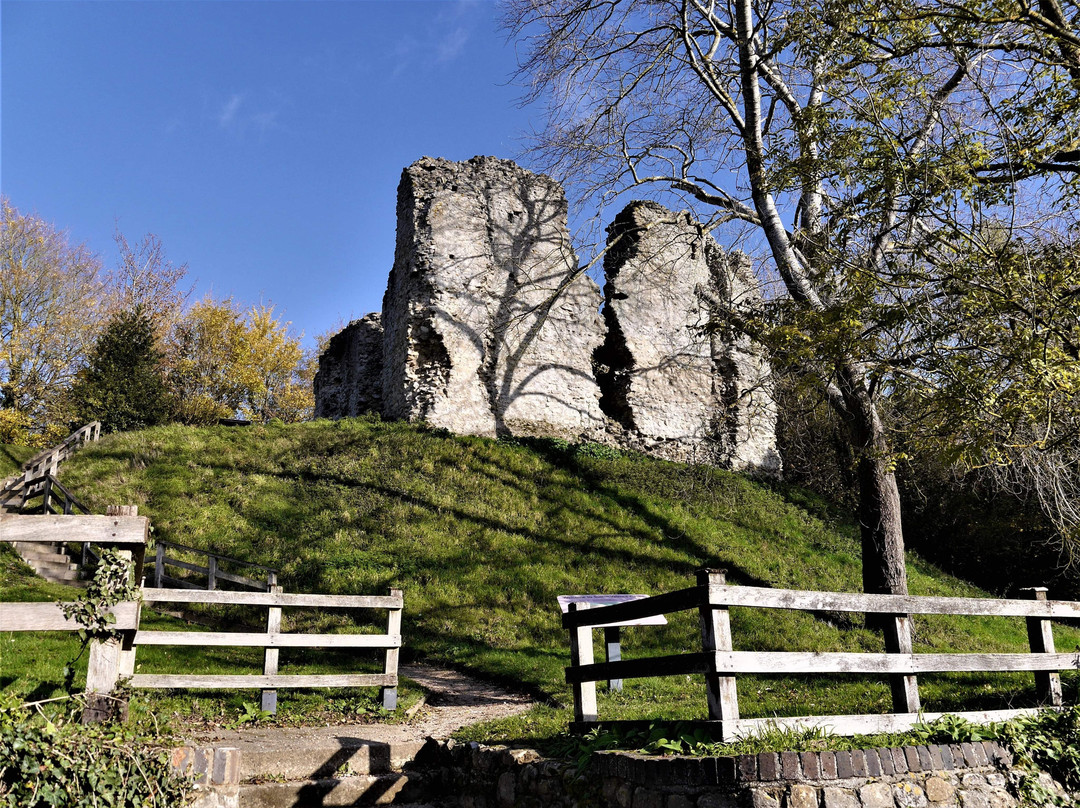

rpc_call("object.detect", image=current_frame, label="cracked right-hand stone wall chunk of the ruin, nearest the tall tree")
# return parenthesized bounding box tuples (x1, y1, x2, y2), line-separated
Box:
(596, 202, 780, 473)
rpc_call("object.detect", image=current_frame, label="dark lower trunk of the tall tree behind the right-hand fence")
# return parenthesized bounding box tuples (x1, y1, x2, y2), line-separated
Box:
(840, 368, 907, 595)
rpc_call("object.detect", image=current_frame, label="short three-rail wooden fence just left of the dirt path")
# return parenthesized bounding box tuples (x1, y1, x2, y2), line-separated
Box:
(131, 587, 403, 712)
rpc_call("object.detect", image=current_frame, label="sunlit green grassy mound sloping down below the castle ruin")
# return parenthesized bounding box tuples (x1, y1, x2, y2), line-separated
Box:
(0, 419, 1076, 733)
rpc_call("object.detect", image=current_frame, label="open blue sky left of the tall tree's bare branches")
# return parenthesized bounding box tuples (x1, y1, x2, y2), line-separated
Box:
(0, 0, 540, 345)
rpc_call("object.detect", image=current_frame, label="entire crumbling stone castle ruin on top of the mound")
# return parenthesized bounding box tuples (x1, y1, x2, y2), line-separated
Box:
(314, 157, 780, 475)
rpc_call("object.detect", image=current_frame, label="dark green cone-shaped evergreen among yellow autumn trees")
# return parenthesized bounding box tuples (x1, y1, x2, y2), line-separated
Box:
(71, 307, 174, 432)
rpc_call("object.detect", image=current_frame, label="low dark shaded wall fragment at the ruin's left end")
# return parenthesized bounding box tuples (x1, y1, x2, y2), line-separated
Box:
(313, 312, 382, 418)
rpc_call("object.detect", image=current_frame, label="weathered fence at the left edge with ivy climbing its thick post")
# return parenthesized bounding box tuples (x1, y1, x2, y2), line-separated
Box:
(0, 514, 150, 721)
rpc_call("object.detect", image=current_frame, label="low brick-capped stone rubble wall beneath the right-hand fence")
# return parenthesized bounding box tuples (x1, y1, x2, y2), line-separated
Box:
(415, 741, 1018, 808)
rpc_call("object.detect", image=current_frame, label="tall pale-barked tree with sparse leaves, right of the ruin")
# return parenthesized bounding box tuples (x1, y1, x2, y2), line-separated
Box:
(508, 0, 1080, 593)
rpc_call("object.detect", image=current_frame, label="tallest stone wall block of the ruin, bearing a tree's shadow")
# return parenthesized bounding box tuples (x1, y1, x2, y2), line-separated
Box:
(382, 158, 603, 439)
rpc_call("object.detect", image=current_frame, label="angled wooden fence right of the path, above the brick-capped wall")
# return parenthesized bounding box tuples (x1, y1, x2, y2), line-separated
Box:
(563, 570, 1080, 740)
